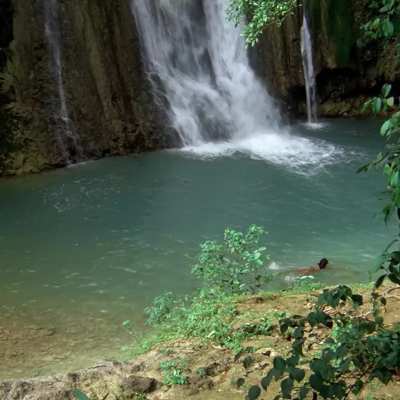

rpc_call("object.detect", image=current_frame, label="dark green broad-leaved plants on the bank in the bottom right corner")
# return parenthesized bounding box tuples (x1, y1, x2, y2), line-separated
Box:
(248, 286, 400, 399)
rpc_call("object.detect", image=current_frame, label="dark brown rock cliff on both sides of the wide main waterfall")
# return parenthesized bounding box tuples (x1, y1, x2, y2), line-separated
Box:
(0, 0, 400, 175)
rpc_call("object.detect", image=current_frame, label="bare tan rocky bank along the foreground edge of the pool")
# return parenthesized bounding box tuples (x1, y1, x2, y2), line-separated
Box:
(0, 289, 400, 400)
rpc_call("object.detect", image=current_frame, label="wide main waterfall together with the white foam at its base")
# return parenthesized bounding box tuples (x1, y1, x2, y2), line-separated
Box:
(131, 0, 337, 167)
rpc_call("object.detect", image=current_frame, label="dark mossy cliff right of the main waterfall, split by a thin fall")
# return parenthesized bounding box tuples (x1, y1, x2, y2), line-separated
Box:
(256, 0, 400, 117)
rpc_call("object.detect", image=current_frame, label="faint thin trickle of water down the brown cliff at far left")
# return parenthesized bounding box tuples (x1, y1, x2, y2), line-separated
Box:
(43, 0, 83, 163)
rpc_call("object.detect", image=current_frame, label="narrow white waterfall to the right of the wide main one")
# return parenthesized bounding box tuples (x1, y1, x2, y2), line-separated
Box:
(301, 7, 318, 123)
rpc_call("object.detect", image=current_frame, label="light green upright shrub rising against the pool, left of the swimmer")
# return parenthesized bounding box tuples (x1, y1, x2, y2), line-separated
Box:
(192, 225, 271, 294)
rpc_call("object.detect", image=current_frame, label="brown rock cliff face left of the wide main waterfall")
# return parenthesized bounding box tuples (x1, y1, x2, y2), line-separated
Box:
(0, 0, 171, 174)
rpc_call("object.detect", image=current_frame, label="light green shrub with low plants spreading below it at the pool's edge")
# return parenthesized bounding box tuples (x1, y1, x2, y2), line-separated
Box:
(124, 225, 278, 354)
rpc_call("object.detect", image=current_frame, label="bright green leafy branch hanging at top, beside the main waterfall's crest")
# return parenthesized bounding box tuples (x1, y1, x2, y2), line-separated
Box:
(228, 0, 297, 45)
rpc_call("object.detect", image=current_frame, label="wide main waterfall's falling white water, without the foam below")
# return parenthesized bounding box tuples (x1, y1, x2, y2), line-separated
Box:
(131, 0, 279, 146)
